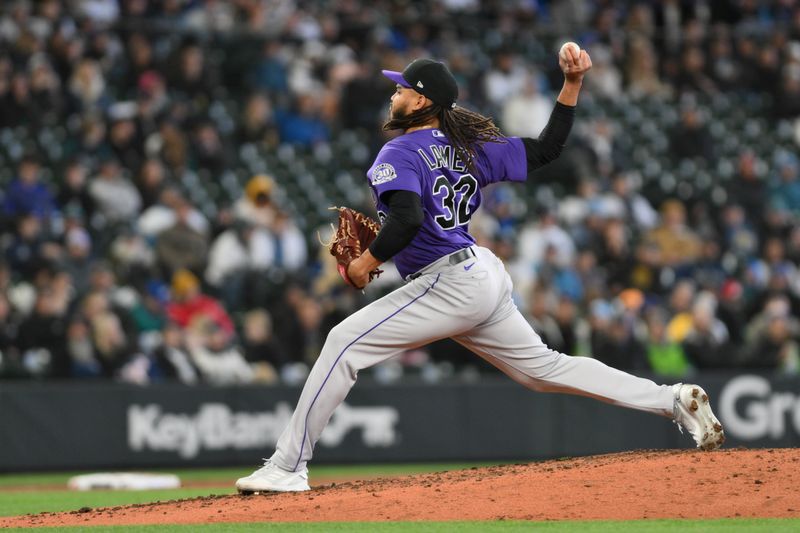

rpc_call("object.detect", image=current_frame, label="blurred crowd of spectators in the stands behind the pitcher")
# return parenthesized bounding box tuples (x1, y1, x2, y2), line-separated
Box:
(0, 0, 800, 384)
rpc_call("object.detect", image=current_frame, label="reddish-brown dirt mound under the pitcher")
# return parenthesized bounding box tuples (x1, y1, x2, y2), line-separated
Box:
(0, 449, 800, 528)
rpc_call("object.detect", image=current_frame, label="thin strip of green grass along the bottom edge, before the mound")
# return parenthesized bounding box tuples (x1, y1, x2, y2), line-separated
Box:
(1, 518, 800, 533)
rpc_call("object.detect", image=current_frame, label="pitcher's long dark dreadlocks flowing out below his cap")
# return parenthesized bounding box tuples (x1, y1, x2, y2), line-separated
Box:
(383, 104, 505, 172)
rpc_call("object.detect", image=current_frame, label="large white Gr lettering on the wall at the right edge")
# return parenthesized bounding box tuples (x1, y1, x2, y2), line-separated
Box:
(712, 375, 800, 441)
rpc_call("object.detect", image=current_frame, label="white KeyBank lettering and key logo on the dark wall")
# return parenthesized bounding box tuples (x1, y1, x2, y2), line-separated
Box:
(127, 402, 399, 459)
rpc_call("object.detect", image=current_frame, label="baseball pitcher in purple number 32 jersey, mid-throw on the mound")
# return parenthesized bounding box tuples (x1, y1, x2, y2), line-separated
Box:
(236, 46, 724, 493)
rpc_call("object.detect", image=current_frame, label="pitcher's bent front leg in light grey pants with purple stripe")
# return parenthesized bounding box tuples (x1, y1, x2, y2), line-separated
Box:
(271, 276, 472, 471)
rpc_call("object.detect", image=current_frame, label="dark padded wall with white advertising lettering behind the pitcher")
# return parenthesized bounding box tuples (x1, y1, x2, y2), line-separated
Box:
(0, 374, 800, 472)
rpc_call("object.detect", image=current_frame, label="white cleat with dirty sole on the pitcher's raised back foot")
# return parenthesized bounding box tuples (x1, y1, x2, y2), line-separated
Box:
(672, 383, 725, 451)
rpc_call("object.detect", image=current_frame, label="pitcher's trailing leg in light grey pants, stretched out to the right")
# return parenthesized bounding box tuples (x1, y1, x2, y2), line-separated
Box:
(455, 310, 674, 417)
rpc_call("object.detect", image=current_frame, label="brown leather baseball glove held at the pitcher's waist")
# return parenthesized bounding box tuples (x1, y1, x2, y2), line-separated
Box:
(327, 207, 383, 289)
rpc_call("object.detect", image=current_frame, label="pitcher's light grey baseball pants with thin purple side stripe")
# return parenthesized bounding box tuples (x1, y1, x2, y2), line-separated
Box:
(271, 246, 673, 471)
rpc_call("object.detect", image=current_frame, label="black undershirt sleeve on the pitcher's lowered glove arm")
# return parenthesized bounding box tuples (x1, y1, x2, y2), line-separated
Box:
(369, 191, 425, 262)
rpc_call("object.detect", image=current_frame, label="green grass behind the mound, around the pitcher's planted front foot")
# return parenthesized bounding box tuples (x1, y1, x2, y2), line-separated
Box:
(0, 463, 497, 516)
